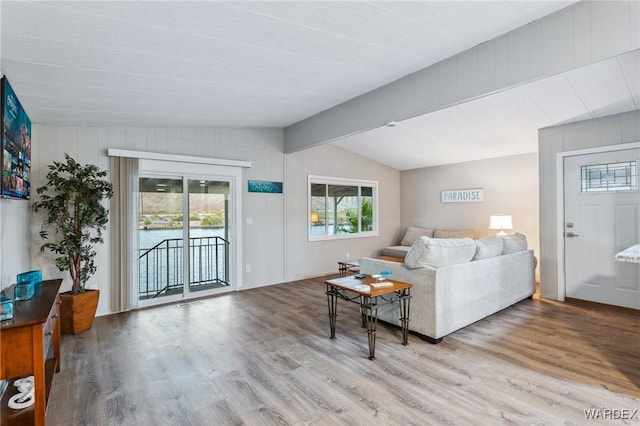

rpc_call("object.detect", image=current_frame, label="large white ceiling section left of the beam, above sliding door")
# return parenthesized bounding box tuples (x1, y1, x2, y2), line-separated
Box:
(1, 1, 572, 127)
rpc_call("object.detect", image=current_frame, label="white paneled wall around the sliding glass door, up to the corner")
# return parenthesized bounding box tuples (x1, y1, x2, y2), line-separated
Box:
(29, 124, 286, 315)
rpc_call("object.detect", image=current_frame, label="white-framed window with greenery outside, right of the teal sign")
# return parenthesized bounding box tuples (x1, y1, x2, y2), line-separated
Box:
(308, 175, 378, 241)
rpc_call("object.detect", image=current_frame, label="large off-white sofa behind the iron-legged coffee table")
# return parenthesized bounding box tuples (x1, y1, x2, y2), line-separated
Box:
(360, 234, 536, 343)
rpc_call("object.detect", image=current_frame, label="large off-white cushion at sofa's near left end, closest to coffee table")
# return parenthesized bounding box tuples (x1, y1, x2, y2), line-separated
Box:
(404, 237, 476, 269)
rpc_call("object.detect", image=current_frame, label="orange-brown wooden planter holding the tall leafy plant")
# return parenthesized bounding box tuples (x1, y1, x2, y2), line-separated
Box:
(60, 290, 100, 334)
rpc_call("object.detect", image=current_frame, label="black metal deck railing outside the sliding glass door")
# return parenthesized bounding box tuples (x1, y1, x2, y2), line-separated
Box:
(139, 237, 229, 300)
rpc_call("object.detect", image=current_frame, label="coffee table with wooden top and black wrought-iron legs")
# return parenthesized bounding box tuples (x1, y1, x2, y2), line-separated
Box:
(325, 275, 413, 360)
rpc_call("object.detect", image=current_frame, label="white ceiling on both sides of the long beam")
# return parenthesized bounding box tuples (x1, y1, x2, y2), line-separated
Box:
(0, 0, 640, 170)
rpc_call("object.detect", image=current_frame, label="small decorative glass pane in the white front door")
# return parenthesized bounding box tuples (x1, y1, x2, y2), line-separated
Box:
(580, 161, 638, 193)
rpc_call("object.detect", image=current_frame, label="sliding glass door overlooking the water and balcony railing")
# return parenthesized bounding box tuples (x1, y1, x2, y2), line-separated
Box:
(138, 174, 233, 306)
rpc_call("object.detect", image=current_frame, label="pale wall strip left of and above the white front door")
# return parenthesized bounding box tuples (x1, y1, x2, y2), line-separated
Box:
(538, 111, 640, 300)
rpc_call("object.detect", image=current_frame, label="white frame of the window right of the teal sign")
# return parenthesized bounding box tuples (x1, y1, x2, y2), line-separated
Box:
(306, 175, 379, 241)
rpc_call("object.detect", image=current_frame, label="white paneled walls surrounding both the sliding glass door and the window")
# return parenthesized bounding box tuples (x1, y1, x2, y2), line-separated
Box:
(8, 124, 400, 315)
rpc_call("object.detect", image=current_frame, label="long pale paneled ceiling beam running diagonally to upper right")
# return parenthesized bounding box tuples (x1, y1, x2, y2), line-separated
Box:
(284, 0, 640, 153)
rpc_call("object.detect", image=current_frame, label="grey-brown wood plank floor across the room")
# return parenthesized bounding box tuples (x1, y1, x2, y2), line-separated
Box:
(47, 279, 640, 426)
